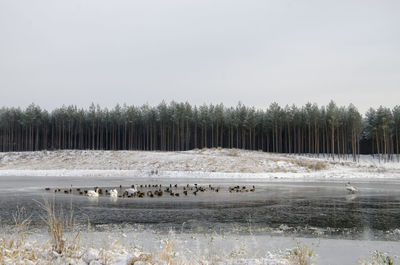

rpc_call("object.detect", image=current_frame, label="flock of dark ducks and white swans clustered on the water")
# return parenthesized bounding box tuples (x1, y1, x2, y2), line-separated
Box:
(45, 184, 256, 198)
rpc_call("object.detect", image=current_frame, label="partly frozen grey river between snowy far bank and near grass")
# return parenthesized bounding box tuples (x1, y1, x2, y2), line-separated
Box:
(0, 174, 400, 264)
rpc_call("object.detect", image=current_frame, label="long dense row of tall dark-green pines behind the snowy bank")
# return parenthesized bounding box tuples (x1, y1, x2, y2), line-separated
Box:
(0, 101, 400, 160)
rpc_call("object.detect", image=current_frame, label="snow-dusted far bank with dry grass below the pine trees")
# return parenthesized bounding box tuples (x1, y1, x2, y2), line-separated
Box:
(0, 148, 400, 181)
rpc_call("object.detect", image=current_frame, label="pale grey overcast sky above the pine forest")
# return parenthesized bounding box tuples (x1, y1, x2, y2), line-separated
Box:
(0, 0, 400, 112)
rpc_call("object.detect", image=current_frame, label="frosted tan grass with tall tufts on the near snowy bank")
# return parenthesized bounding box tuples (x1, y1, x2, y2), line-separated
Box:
(0, 201, 291, 265)
